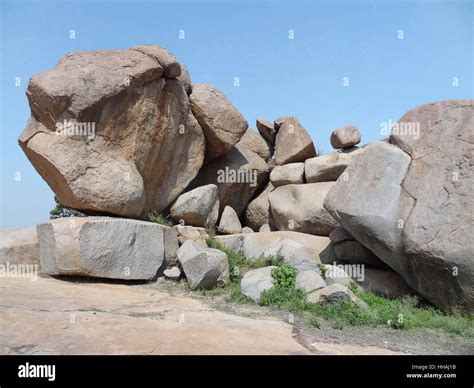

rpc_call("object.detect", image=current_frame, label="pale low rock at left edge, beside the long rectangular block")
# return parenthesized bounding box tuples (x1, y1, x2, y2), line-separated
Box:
(0, 226, 39, 265)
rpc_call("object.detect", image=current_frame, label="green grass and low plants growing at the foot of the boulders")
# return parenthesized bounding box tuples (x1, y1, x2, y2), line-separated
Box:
(203, 233, 474, 338)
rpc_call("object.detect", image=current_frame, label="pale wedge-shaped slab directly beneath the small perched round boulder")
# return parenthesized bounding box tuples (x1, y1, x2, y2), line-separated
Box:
(304, 147, 363, 183)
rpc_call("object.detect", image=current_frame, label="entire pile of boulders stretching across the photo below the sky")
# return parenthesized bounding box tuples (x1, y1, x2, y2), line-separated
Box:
(0, 45, 474, 310)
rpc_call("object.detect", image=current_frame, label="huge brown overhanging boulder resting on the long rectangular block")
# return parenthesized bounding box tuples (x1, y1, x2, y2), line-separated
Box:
(19, 46, 205, 217)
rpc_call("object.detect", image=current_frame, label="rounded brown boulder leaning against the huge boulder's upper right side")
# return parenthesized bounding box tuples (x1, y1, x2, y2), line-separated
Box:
(189, 84, 248, 160)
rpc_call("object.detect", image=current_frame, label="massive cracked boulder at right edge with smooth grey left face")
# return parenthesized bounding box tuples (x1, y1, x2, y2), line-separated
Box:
(324, 100, 474, 311)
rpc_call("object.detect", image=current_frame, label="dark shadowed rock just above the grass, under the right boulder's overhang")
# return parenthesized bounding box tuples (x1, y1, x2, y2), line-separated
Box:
(354, 267, 415, 299)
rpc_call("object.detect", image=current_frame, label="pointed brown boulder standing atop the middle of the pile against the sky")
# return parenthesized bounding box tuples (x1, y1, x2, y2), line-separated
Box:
(275, 117, 316, 165)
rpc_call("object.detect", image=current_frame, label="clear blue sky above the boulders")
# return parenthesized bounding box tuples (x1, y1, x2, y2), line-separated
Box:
(0, 0, 474, 227)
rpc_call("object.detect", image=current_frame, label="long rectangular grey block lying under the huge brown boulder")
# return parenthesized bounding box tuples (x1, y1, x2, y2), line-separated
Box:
(37, 217, 174, 280)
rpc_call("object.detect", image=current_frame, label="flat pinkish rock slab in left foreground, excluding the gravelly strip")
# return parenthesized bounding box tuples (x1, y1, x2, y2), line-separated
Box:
(0, 278, 310, 355)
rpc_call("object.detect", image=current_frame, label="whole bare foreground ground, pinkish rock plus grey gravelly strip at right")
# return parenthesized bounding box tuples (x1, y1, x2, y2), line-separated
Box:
(0, 277, 474, 355)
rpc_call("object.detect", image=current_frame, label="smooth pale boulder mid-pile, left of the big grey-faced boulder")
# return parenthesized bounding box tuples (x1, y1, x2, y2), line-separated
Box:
(268, 182, 338, 236)
